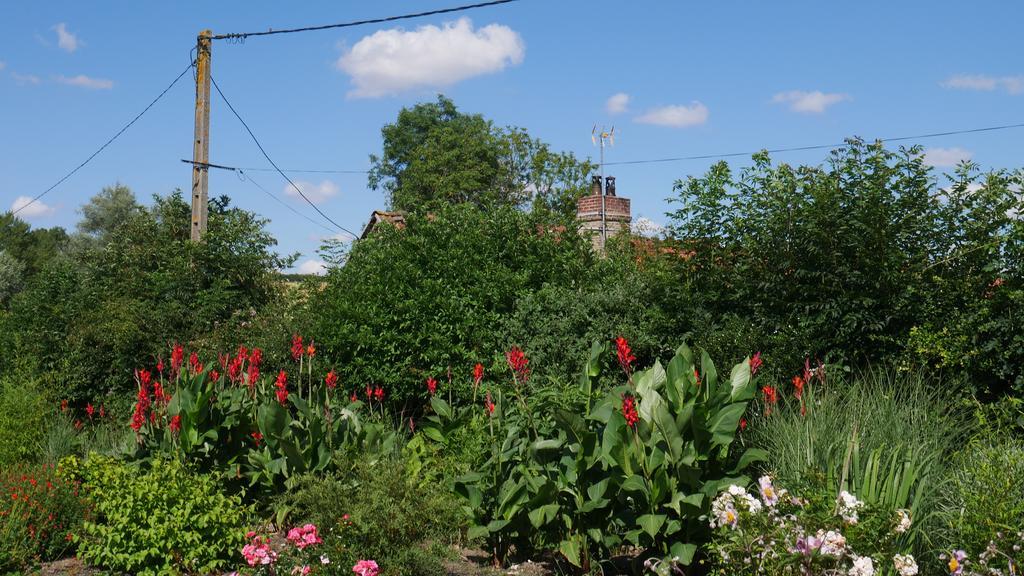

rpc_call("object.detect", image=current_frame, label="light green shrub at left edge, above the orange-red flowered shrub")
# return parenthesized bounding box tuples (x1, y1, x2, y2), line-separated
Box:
(0, 377, 51, 466)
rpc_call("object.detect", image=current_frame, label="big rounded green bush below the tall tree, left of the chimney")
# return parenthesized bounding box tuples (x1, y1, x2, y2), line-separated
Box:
(308, 204, 590, 406)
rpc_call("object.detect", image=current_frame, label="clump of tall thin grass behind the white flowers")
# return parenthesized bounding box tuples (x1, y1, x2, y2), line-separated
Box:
(752, 367, 971, 538)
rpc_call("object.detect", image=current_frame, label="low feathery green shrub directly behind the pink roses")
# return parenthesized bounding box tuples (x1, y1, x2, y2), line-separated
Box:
(282, 458, 462, 576)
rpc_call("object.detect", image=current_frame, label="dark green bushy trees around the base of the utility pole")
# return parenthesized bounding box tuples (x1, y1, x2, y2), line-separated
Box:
(2, 193, 290, 406)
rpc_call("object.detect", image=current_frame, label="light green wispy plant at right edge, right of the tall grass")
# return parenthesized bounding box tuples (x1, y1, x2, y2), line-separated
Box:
(934, 439, 1024, 560)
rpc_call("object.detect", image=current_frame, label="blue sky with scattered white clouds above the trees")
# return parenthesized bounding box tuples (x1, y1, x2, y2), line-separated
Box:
(0, 0, 1024, 270)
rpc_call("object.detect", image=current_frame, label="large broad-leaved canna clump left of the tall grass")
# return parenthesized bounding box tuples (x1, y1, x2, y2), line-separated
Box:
(456, 343, 763, 570)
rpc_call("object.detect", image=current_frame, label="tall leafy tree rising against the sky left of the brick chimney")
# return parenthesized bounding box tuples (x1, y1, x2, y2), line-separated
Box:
(370, 95, 593, 214)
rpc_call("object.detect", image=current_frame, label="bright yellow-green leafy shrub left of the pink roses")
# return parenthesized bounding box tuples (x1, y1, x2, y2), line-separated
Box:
(76, 455, 247, 574)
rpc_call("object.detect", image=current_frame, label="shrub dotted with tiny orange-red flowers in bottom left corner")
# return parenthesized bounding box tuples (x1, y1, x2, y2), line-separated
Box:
(0, 464, 85, 573)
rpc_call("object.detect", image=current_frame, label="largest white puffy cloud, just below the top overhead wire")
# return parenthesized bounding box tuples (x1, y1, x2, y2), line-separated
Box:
(337, 17, 526, 97)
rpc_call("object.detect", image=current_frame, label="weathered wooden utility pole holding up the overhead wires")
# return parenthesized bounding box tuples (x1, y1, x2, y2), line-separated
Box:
(191, 30, 213, 242)
